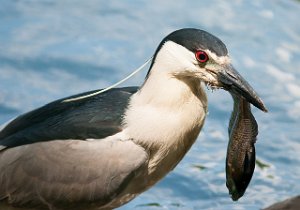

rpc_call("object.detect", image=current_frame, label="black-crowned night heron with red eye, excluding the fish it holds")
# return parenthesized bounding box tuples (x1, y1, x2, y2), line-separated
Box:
(0, 29, 265, 210)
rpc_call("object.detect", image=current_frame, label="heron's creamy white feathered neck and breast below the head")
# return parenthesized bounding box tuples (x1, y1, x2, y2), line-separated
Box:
(124, 67, 207, 174)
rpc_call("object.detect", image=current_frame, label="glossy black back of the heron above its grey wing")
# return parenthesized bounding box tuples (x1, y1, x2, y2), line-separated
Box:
(0, 87, 138, 150)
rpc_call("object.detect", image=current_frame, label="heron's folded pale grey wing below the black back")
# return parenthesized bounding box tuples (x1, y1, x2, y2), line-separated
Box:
(0, 137, 148, 209)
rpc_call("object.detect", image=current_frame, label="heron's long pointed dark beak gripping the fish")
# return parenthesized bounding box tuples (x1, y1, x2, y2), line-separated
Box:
(218, 65, 268, 112)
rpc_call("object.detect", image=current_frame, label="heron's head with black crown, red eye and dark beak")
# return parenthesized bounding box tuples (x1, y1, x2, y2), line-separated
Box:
(147, 28, 267, 112)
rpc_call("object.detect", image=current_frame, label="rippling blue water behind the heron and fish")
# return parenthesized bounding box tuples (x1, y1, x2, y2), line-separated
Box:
(0, 0, 300, 210)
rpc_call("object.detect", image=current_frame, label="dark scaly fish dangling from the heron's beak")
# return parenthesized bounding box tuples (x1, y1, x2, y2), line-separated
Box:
(226, 93, 258, 201)
